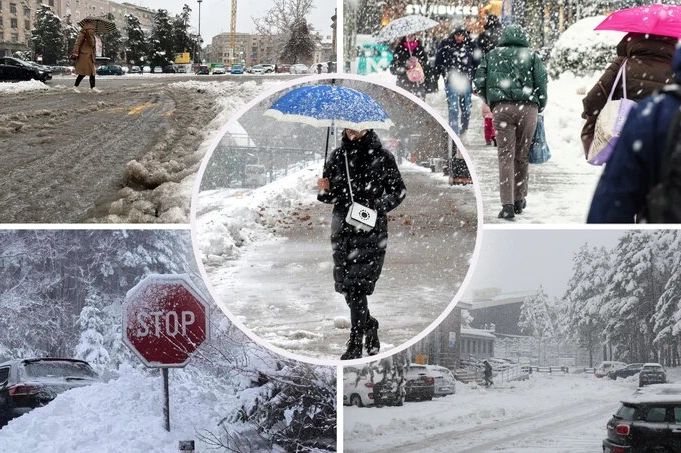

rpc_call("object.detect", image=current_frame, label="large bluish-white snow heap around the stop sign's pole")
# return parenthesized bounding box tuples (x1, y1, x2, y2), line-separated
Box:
(0, 368, 235, 453)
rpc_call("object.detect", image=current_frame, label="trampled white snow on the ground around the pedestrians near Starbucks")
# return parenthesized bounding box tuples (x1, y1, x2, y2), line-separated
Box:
(368, 72, 602, 225)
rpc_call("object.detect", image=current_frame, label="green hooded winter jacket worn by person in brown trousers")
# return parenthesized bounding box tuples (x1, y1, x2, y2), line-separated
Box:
(473, 25, 547, 112)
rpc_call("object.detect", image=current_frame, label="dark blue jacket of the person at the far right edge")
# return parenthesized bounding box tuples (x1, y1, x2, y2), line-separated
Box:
(587, 48, 681, 223)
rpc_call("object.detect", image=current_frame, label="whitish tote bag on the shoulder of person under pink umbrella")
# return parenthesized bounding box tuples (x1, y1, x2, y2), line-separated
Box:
(587, 60, 636, 165)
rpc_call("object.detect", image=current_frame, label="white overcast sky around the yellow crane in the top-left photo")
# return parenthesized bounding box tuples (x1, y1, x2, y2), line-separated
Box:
(114, 0, 336, 44)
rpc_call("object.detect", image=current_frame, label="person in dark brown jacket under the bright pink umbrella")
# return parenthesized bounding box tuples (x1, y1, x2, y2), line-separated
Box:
(581, 33, 677, 156)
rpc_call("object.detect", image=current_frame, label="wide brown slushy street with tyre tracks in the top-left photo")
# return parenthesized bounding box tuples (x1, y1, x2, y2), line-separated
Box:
(0, 74, 283, 223)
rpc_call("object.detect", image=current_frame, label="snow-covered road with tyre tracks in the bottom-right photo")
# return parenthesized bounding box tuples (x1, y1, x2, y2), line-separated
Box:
(343, 375, 637, 453)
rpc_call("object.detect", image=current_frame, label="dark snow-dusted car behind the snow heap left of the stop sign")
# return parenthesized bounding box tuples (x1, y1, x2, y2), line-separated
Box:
(0, 358, 99, 426)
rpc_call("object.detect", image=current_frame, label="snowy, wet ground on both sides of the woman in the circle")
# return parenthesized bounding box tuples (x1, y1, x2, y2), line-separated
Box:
(197, 163, 477, 359)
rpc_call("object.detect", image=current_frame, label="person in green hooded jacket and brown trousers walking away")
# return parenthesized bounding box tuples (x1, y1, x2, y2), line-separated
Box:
(473, 25, 547, 220)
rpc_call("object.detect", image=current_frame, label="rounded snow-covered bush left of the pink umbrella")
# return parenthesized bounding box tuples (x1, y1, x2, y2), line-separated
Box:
(548, 16, 623, 79)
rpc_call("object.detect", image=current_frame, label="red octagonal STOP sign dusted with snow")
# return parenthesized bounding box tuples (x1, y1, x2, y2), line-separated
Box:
(123, 274, 208, 368)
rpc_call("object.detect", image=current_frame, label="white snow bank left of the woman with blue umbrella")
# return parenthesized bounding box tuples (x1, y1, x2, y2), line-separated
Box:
(196, 163, 319, 266)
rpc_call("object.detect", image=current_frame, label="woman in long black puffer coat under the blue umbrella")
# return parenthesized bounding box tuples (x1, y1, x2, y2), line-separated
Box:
(317, 129, 407, 360)
